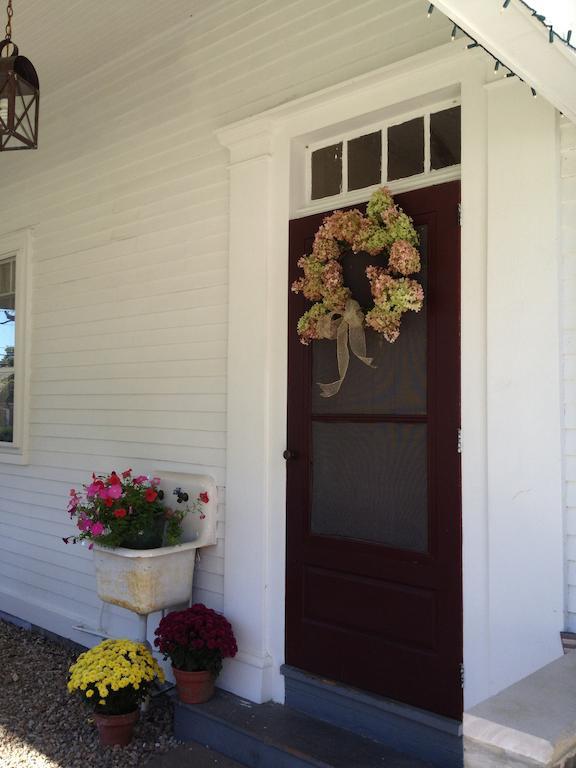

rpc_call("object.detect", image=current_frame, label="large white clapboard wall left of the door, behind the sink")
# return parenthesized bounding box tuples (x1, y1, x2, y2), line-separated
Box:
(0, 0, 450, 643)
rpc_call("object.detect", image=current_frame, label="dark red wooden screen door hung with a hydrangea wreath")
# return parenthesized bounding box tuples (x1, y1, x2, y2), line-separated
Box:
(286, 182, 462, 718)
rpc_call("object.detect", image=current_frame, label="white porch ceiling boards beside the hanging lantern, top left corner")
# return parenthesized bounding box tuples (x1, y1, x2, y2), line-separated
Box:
(5, 0, 217, 94)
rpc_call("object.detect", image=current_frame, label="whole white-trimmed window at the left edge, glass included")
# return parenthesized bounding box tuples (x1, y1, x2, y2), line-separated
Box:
(0, 232, 29, 463)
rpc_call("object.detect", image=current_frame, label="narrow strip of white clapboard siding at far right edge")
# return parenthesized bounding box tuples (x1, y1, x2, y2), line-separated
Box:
(560, 115, 576, 632)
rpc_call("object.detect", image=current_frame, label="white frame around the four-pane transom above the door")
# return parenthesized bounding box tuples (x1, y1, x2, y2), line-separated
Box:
(301, 97, 461, 210)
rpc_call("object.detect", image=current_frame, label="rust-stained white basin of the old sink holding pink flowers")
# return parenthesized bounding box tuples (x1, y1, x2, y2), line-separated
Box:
(94, 542, 198, 615)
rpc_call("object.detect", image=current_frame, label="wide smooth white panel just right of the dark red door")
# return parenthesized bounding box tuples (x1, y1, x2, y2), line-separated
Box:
(486, 81, 564, 692)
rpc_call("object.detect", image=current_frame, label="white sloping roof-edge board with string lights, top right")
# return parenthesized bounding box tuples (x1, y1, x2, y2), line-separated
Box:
(434, 0, 576, 122)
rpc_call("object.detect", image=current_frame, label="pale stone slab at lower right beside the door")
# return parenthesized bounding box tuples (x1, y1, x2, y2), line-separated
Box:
(464, 652, 576, 768)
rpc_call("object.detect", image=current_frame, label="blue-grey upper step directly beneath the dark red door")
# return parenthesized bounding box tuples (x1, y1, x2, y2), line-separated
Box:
(282, 666, 463, 768)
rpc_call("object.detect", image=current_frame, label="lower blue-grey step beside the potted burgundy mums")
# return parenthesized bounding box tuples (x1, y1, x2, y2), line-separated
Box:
(174, 691, 430, 768)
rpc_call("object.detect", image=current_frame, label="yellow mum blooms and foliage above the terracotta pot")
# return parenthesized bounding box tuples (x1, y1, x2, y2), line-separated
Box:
(68, 640, 164, 715)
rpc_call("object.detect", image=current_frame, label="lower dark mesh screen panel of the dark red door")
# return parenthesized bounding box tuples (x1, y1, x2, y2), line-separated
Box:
(311, 422, 428, 552)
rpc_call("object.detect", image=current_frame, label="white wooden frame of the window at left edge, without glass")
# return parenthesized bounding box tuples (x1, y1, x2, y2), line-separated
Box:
(0, 230, 31, 464)
